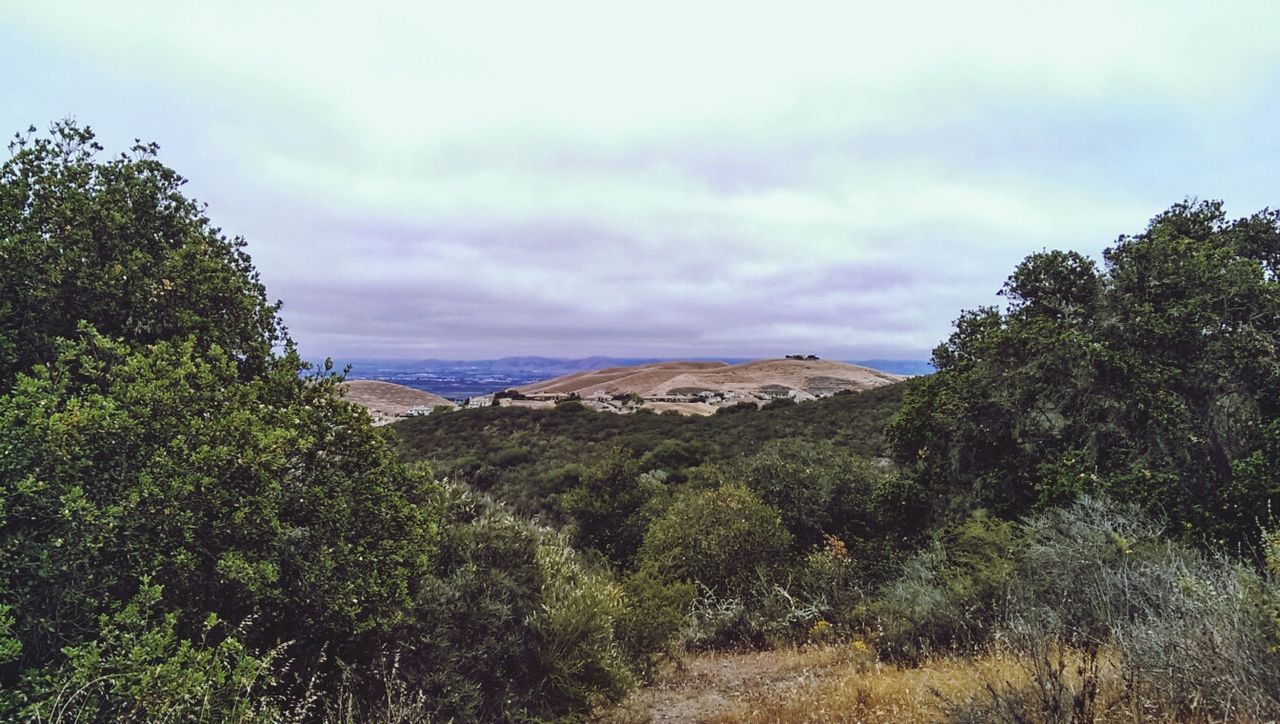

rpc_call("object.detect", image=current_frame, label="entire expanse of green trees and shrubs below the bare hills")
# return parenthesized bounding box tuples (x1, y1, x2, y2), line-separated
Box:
(0, 123, 1280, 721)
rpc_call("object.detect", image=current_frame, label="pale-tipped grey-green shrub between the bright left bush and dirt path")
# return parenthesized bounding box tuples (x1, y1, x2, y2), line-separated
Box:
(391, 486, 632, 721)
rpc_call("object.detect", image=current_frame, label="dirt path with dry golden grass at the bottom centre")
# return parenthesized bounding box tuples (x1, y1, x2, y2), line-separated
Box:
(600, 649, 847, 724)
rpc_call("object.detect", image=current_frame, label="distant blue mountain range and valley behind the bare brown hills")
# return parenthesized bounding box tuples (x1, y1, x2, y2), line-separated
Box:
(335, 357, 933, 400)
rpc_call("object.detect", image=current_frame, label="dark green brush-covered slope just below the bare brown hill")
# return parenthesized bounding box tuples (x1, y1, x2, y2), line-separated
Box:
(392, 382, 911, 522)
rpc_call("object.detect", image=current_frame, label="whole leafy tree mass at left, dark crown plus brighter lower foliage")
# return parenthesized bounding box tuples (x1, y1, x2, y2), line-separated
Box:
(0, 123, 438, 719)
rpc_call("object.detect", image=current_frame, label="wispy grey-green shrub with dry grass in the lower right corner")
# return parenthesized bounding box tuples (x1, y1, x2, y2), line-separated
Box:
(936, 498, 1280, 721)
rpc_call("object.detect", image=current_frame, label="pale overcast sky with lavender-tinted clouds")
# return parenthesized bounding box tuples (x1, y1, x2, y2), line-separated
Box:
(0, 0, 1280, 359)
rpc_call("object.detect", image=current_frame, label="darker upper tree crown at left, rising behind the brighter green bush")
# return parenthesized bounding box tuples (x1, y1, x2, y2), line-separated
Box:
(0, 122, 284, 394)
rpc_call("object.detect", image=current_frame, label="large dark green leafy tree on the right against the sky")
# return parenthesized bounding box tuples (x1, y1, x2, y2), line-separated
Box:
(890, 202, 1280, 540)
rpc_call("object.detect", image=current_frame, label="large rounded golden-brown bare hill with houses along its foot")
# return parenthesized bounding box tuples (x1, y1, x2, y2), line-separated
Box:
(520, 359, 905, 404)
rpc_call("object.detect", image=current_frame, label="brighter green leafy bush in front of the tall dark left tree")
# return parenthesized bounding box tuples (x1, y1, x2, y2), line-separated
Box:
(0, 329, 435, 695)
